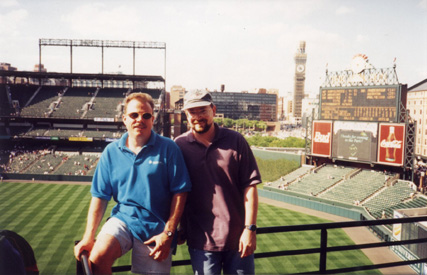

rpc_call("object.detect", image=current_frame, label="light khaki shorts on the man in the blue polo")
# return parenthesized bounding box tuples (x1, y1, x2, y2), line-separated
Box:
(99, 218, 172, 274)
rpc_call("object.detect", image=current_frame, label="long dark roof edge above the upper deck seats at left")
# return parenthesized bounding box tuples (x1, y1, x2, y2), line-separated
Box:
(0, 70, 165, 82)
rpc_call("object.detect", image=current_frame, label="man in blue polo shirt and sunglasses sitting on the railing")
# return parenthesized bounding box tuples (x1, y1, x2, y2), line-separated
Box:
(74, 93, 191, 274)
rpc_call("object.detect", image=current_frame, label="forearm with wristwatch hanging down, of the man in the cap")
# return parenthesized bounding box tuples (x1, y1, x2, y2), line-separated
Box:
(239, 185, 258, 258)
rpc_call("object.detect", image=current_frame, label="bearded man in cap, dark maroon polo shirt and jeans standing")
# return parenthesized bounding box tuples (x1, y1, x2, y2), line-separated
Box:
(175, 91, 261, 274)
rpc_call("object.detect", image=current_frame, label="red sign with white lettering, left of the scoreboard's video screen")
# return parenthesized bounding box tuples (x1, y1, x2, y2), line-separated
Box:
(311, 121, 332, 157)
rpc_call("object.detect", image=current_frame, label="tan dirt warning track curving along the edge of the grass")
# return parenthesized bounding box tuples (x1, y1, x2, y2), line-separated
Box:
(259, 196, 417, 275)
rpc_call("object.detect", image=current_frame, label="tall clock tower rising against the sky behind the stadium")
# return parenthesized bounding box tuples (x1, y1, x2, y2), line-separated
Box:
(292, 41, 307, 119)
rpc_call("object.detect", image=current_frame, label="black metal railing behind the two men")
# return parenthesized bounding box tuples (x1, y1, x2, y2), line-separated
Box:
(76, 216, 427, 274)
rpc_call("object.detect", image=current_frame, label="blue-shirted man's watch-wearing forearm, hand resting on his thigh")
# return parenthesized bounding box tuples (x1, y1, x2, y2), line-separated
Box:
(144, 192, 187, 261)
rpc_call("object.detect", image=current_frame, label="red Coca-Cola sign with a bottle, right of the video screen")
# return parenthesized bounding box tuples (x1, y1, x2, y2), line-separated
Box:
(378, 123, 405, 166)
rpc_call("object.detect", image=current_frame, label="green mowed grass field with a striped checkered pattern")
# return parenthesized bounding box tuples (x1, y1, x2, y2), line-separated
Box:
(0, 182, 380, 274)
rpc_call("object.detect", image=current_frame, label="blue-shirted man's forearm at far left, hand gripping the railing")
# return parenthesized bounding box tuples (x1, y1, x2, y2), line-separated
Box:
(74, 197, 108, 260)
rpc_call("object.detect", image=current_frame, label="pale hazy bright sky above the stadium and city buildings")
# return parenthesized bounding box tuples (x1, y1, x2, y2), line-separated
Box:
(0, 0, 427, 96)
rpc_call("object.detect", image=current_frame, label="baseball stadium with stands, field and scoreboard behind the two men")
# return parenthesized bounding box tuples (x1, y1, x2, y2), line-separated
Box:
(0, 39, 427, 274)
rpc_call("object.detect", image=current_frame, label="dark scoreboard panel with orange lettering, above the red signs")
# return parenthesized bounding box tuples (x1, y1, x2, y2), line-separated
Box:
(319, 85, 406, 122)
